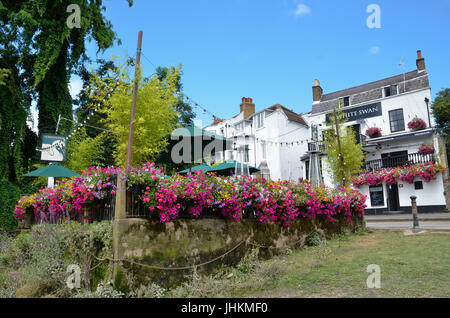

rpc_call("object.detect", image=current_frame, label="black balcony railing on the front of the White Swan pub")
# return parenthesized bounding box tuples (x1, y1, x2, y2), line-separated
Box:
(364, 153, 435, 171)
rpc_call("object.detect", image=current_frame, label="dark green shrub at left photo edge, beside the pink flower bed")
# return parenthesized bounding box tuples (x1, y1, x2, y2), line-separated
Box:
(0, 180, 21, 231)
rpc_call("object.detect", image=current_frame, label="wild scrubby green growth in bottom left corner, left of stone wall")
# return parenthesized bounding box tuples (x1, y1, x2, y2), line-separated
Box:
(0, 221, 113, 298)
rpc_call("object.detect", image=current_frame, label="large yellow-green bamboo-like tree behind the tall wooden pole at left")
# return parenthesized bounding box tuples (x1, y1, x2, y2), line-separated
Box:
(90, 63, 181, 167)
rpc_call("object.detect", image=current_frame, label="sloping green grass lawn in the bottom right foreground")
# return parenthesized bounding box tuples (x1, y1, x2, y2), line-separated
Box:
(169, 231, 450, 297)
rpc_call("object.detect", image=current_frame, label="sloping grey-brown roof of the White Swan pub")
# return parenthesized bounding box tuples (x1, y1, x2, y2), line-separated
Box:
(312, 70, 428, 114)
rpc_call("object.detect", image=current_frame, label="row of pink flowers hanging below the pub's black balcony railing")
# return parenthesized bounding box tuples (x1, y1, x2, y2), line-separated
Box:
(352, 163, 445, 188)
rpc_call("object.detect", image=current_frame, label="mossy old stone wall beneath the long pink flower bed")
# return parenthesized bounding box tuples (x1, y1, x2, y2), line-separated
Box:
(114, 217, 364, 292)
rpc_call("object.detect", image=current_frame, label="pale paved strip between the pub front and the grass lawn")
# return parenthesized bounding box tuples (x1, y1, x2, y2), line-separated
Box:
(365, 213, 450, 231)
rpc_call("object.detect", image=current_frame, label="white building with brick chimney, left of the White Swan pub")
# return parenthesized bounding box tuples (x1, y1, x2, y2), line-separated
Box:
(205, 97, 309, 181)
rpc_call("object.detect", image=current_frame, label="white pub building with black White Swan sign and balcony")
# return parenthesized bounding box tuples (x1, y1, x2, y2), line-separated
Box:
(305, 51, 447, 213)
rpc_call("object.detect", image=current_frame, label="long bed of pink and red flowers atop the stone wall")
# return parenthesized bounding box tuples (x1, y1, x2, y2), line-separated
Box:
(15, 163, 366, 226)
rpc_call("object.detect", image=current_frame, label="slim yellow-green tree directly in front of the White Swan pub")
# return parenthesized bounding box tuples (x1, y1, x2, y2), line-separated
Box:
(323, 102, 364, 187)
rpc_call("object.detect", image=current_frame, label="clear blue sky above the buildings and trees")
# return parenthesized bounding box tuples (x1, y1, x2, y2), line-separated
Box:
(68, 0, 450, 125)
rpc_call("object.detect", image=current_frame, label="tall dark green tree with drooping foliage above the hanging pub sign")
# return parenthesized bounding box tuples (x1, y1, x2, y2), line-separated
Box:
(0, 0, 133, 133)
